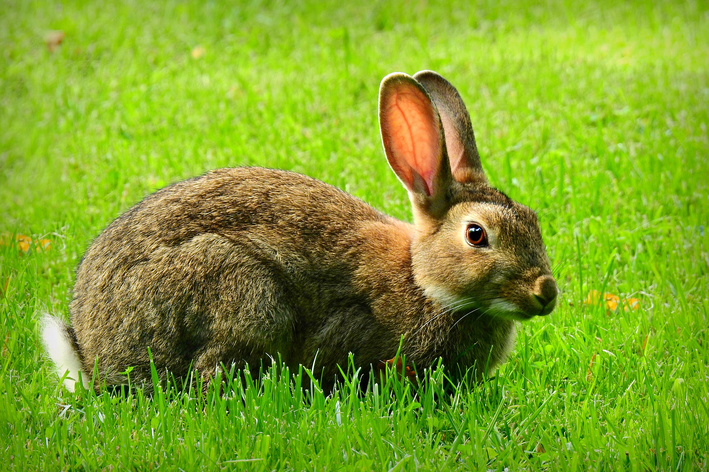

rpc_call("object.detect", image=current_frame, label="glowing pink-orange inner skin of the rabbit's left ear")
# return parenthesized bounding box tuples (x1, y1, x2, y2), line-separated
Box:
(385, 88, 441, 196)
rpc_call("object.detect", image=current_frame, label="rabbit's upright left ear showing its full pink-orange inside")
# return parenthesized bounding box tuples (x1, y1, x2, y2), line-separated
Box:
(379, 73, 451, 207)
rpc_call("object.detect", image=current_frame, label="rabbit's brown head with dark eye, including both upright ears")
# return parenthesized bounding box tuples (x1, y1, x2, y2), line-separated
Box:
(379, 71, 558, 319)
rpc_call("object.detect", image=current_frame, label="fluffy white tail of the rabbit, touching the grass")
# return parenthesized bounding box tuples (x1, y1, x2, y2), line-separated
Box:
(42, 314, 89, 392)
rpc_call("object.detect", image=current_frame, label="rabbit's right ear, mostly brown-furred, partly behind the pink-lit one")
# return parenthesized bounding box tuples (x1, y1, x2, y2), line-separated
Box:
(414, 70, 487, 183)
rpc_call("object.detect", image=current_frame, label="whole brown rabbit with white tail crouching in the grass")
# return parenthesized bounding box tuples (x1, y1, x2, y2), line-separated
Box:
(43, 71, 557, 389)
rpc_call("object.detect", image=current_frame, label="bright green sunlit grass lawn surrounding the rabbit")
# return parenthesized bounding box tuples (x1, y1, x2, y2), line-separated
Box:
(0, 0, 709, 470)
